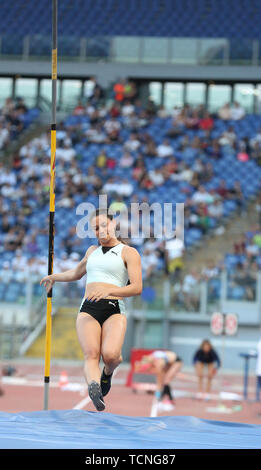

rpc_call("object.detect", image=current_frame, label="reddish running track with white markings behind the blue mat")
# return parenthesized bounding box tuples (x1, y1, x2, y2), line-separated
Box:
(0, 360, 261, 424)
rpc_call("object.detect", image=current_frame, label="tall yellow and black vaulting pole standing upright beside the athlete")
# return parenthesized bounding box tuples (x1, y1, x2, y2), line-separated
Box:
(44, 0, 57, 410)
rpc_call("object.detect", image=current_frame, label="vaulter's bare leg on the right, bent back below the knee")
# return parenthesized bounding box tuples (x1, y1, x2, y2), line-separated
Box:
(101, 313, 127, 375)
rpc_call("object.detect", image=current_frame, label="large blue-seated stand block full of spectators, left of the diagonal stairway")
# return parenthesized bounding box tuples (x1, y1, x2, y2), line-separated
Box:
(0, 88, 261, 299)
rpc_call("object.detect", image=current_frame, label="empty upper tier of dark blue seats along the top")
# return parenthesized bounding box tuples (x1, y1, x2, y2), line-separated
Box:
(0, 0, 261, 39)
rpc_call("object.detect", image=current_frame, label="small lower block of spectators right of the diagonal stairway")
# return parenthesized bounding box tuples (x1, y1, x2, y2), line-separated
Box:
(171, 224, 261, 311)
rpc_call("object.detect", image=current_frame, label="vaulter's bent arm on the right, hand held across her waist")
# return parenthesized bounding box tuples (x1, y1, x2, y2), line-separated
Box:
(110, 245, 142, 297)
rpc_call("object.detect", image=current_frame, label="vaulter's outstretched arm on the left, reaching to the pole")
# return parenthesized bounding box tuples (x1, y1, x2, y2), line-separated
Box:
(40, 245, 96, 292)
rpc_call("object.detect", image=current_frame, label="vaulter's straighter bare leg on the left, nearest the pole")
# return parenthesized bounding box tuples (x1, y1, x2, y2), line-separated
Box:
(76, 313, 101, 384)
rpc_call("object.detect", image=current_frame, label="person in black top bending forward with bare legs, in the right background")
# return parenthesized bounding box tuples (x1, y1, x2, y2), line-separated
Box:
(193, 340, 220, 398)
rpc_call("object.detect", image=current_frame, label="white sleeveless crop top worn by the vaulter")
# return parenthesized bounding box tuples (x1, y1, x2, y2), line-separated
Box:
(86, 243, 128, 287)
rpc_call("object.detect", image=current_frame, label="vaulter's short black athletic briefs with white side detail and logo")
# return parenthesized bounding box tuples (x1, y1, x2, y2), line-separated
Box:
(79, 299, 125, 326)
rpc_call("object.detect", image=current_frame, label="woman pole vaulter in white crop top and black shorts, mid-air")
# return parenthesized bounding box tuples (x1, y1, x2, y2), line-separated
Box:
(40, 209, 142, 411)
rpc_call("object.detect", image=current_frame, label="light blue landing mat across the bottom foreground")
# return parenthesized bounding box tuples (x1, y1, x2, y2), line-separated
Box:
(0, 410, 261, 449)
